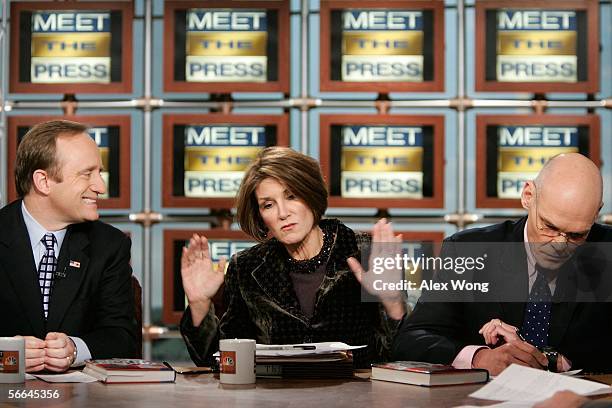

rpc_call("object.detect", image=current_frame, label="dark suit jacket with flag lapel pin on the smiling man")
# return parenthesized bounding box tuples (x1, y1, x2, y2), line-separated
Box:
(0, 200, 138, 358)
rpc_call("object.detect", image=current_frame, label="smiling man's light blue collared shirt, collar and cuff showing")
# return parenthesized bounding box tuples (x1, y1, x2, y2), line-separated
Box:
(21, 201, 91, 367)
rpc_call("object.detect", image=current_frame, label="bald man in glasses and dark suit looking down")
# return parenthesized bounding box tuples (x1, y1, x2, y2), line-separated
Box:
(393, 153, 612, 375)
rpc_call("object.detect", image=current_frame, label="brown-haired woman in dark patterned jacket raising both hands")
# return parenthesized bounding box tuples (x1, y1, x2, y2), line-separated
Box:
(180, 147, 405, 367)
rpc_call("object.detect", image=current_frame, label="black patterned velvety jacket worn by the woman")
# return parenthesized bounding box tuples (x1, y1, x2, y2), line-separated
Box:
(180, 219, 397, 367)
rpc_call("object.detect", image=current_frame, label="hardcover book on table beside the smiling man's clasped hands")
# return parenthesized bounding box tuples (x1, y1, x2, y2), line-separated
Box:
(83, 358, 176, 384)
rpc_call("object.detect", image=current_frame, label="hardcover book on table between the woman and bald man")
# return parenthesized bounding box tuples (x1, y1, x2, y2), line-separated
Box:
(371, 361, 489, 387)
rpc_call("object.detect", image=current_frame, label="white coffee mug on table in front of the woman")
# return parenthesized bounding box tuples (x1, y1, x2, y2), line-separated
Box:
(219, 339, 255, 384)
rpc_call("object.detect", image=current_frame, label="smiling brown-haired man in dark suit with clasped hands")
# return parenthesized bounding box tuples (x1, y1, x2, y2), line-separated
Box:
(0, 121, 138, 372)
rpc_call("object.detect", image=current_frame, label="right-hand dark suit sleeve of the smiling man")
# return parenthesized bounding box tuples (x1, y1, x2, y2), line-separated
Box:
(80, 234, 140, 359)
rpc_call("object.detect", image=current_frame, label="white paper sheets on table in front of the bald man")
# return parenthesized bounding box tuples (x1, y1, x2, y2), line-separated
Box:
(470, 364, 612, 402)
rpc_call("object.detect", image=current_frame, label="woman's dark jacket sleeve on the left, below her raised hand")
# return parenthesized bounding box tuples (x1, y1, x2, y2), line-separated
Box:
(180, 256, 256, 366)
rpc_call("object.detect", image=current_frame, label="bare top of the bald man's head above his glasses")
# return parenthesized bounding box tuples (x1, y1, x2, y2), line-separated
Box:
(535, 153, 603, 215)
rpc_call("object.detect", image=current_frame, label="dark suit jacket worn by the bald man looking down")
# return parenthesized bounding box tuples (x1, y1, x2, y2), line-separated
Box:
(392, 218, 612, 371)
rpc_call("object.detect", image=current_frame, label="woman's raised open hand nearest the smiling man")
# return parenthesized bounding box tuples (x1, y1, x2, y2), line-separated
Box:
(181, 234, 227, 326)
